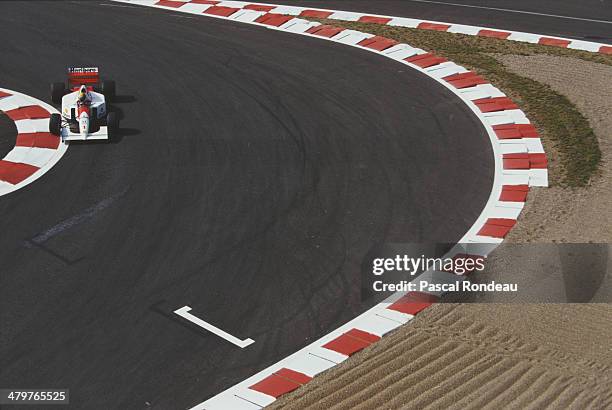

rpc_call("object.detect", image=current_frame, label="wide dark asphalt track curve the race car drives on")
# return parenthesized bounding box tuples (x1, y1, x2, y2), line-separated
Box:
(0, 1, 493, 409)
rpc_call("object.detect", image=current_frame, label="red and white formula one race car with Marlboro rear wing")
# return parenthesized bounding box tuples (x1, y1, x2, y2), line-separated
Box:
(49, 67, 119, 141)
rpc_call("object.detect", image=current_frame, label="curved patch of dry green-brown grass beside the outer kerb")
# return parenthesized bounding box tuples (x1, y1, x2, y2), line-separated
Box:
(310, 18, 612, 187)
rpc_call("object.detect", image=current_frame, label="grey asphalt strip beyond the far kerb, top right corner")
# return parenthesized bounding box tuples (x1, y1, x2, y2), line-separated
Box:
(264, 0, 612, 43)
